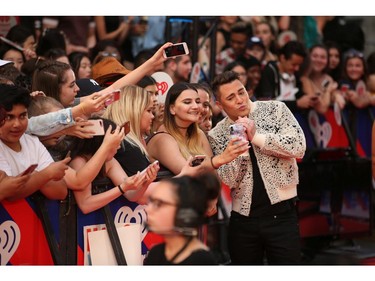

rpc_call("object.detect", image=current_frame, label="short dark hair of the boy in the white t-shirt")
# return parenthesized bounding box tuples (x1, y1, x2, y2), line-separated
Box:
(0, 84, 31, 111)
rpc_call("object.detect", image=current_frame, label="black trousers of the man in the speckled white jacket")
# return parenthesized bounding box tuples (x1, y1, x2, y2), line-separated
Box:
(228, 209, 301, 265)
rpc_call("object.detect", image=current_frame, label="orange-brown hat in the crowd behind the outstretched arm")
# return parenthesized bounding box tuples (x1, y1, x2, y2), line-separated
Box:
(92, 57, 130, 87)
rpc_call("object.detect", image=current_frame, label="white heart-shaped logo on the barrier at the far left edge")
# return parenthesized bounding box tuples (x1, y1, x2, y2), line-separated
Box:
(0, 220, 21, 265)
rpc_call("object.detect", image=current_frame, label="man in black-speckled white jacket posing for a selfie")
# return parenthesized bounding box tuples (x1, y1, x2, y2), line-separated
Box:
(208, 71, 306, 265)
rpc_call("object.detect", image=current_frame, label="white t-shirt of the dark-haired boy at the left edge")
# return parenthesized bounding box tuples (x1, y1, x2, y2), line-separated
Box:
(0, 134, 54, 176)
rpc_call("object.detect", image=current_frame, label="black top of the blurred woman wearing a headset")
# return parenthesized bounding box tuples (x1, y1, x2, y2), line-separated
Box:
(143, 243, 218, 265)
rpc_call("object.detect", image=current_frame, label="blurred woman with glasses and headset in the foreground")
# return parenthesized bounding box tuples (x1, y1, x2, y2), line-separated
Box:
(144, 173, 220, 265)
